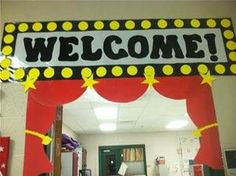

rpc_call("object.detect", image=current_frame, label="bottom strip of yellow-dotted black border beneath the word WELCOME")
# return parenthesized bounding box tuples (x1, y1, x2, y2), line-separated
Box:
(0, 63, 236, 82)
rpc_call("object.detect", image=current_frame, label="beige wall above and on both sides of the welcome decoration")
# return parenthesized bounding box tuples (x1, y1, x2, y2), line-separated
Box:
(0, 0, 236, 176)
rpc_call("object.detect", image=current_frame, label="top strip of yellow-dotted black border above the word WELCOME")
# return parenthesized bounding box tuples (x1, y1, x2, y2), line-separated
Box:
(4, 18, 232, 34)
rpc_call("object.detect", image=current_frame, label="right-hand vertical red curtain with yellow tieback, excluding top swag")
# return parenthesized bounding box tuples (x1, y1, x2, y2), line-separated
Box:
(186, 79, 223, 170)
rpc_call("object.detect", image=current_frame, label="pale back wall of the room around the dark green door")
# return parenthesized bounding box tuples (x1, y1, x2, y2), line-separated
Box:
(79, 131, 199, 176)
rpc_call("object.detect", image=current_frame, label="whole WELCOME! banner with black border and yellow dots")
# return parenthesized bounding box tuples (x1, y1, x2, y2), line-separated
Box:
(0, 18, 236, 81)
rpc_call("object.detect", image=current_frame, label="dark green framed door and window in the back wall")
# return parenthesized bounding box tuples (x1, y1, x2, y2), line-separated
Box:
(99, 144, 147, 176)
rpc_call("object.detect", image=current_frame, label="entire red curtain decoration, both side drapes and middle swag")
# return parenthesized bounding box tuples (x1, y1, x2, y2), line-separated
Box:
(24, 76, 223, 176)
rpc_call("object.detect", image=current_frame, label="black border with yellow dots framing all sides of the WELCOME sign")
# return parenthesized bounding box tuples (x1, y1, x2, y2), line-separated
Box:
(0, 18, 236, 81)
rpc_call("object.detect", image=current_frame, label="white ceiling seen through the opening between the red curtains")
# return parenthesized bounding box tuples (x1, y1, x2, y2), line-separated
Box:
(63, 89, 195, 134)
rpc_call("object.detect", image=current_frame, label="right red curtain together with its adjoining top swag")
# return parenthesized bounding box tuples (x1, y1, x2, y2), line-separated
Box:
(154, 76, 223, 170)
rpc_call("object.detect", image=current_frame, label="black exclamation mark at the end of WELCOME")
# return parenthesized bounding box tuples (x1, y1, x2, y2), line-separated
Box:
(204, 34, 218, 61)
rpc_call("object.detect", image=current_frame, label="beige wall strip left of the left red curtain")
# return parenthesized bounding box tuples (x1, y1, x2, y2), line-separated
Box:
(0, 84, 27, 176)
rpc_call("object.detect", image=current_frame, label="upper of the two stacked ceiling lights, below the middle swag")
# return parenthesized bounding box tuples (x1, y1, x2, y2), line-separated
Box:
(94, 107, 118, 120)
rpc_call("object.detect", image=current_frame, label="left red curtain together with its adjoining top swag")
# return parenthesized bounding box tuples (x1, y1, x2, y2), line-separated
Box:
(23, 80, 85, 176)
